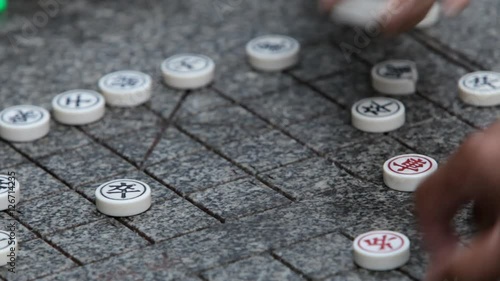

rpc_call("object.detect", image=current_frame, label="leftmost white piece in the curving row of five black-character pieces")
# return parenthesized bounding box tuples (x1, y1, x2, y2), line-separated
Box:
(0, 105, 50, 142)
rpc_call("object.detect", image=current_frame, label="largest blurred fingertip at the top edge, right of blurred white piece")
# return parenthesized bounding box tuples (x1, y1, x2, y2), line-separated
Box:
(384, 0, 438, 35)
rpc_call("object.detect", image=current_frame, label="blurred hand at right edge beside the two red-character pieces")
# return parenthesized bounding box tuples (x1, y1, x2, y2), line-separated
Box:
(416, 121, 500, 281)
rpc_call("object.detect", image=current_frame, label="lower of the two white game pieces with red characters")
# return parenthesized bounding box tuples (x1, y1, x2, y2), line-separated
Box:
(353, 230, 410, 271)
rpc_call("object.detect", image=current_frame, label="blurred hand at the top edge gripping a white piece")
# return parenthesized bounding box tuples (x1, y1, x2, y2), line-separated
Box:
(319, 0, 469, 35)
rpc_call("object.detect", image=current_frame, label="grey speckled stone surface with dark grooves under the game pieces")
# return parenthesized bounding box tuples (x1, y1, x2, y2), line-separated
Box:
(0, 0, 494, 281)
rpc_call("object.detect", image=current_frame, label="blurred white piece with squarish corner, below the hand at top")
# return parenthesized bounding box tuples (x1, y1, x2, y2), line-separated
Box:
(372, 60, 418, 95)
